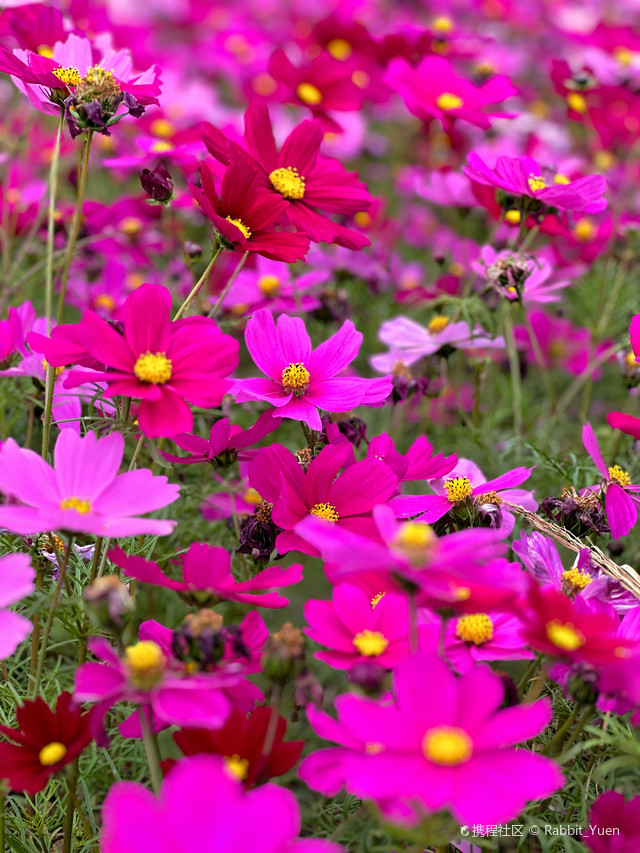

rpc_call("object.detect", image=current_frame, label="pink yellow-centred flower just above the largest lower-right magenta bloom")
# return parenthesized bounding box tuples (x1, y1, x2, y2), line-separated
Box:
(304, 583, 438, 669)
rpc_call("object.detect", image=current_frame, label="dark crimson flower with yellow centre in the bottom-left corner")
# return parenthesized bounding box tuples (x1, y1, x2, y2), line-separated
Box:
(0, 693, 98, 794)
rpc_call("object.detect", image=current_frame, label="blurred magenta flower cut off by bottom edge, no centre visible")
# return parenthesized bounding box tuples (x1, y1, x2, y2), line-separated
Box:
(100, 755, 344, 853)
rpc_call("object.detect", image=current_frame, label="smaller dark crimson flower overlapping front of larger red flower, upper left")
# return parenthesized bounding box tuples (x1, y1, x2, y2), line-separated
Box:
(189, 162, 309, 264)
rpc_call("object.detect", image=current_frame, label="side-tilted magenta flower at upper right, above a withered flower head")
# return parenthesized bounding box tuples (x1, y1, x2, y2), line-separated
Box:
(462, 151, 607, 213)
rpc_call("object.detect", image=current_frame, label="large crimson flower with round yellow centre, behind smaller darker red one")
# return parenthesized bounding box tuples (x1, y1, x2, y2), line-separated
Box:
(203, 103, 373, 249)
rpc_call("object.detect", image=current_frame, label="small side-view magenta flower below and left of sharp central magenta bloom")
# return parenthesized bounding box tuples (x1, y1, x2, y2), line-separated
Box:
(161, 412, 280, 468)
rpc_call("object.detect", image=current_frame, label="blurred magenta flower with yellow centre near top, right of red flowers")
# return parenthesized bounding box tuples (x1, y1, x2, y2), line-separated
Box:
(385, 56, 518, 129)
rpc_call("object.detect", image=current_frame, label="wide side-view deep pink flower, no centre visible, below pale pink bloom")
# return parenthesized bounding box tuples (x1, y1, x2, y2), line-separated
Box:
(109, 542, 302, 607)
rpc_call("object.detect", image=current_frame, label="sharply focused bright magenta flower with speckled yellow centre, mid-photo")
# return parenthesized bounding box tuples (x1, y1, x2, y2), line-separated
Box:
(231, 308, 391, 431)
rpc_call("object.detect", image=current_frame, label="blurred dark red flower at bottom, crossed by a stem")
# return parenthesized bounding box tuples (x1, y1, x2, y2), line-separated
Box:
(173, 705, 305, 788)
